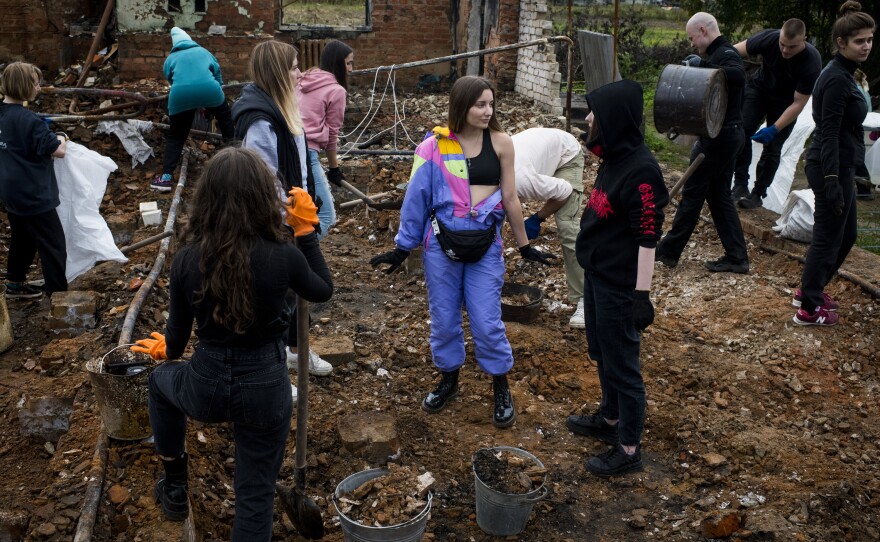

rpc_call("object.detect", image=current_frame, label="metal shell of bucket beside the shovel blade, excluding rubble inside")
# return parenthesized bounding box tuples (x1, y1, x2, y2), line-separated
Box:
(333, 469, 431, 542)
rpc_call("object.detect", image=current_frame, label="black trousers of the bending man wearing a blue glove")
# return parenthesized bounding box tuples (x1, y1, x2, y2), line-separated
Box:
(733, 85, 795, 198)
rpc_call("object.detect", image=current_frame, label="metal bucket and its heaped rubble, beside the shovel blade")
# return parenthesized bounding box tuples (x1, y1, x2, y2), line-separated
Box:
(333, 464, 434, 542)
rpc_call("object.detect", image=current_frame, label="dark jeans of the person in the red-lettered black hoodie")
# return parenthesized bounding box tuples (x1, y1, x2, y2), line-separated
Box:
(584, 273, 645, 446)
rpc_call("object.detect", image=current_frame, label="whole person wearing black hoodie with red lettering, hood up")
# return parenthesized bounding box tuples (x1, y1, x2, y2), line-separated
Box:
(566, 80, 669, 476)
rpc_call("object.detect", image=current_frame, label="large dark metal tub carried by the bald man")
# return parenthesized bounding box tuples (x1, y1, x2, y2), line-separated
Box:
(654, 64, 727, 138)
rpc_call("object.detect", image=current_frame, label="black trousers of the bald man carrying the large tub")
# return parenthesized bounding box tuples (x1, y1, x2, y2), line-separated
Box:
(657, 124, 749, 262)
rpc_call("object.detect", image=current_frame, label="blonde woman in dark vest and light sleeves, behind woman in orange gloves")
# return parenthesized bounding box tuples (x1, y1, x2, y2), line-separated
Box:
(232, 40, 333, 378)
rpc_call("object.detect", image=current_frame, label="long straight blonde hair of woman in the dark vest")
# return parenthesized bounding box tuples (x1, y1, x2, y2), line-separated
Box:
(250, 40, 303, 136)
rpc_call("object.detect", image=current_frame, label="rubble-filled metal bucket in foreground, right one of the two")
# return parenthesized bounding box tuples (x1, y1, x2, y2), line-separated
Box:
(472, 446, 547, 536)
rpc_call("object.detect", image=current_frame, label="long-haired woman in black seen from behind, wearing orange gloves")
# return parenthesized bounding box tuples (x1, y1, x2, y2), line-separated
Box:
(132, 148, 333, 542)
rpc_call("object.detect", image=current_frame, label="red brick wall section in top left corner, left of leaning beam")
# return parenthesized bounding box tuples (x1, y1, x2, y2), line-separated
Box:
(0, 0, 94, 73)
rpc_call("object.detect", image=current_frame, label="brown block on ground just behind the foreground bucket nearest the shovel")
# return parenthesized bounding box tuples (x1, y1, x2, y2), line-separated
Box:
(337, 411, 400, 465)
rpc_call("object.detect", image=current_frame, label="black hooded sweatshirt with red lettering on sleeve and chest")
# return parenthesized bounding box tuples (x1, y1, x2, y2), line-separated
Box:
(575, 80, 669, 288)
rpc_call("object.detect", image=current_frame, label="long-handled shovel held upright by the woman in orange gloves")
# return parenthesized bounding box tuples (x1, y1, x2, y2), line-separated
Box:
(275, 296, 324, 540)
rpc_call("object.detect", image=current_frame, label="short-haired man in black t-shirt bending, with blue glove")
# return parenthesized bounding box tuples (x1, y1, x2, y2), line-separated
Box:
(733, 19, 822, 209)
